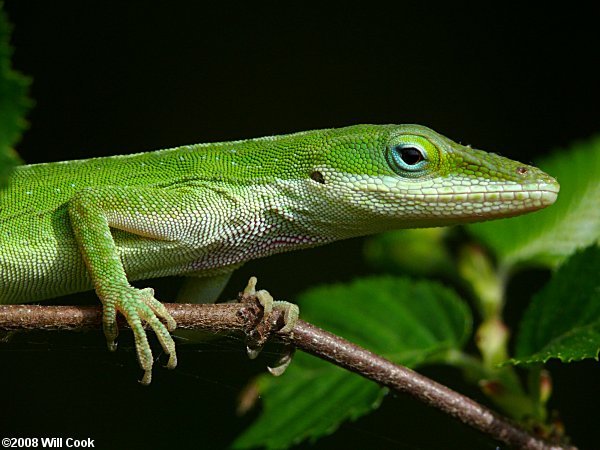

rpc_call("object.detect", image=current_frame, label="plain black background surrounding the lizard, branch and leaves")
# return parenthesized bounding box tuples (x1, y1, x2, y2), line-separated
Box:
(0, 1, 600, 449)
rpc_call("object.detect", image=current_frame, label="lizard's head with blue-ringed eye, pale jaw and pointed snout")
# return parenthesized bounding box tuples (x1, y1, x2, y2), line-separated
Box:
(311, 125, 559, 228)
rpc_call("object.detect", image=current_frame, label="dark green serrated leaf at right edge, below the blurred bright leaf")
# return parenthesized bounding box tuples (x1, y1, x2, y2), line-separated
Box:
(511, 246, 600, 364)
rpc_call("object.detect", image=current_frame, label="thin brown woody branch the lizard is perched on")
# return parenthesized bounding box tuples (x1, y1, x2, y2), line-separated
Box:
(0, 296, 575, 450)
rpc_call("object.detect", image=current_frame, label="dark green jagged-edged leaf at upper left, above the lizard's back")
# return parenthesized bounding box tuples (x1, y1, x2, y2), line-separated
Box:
(0, 2, 32, 186)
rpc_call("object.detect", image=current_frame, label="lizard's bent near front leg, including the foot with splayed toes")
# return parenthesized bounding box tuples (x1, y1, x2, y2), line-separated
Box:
(68, 187, 197, 384)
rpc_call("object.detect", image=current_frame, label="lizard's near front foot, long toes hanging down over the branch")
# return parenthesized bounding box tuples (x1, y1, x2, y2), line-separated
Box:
(102, 286, 177, 384)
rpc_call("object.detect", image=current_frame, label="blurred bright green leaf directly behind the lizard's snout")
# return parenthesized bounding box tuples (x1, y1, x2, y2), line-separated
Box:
(469, 136, 600, 268)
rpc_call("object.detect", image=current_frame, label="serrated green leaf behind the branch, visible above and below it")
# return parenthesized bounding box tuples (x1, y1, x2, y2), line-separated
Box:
(234, 277, 471, 449)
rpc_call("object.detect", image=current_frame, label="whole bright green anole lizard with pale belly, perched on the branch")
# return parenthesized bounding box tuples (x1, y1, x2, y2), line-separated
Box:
(0, 125, 559, 384)
